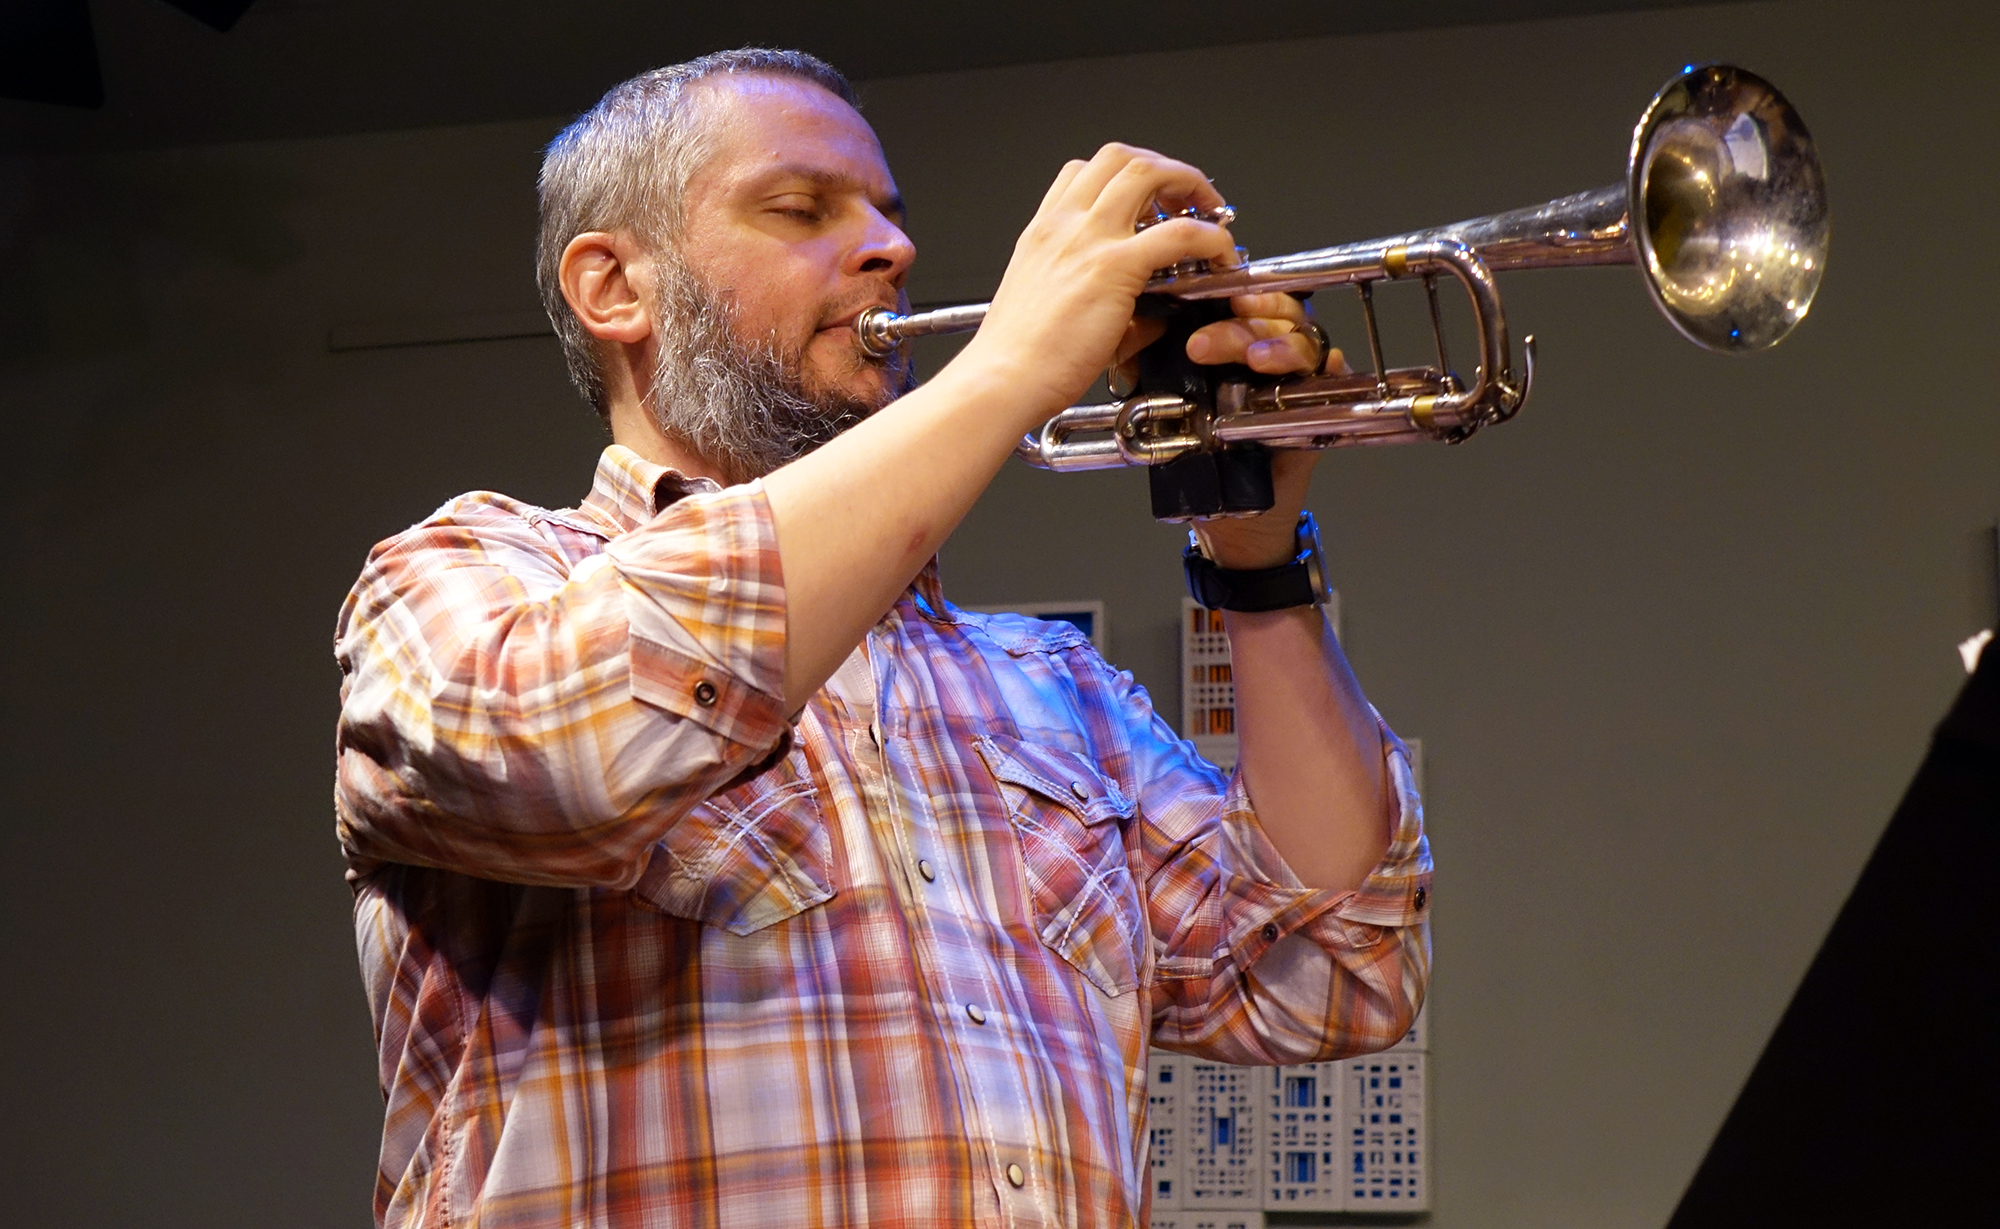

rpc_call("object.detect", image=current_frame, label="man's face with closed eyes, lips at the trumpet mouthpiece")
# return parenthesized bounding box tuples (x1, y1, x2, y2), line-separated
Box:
(678, 76, 916, 406)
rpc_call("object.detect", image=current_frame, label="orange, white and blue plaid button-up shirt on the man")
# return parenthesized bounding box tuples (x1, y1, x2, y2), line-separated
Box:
(336, 446, 1430, 1229)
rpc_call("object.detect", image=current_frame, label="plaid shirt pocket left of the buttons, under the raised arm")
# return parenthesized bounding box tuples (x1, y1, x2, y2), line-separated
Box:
(632, 751, 834, 935)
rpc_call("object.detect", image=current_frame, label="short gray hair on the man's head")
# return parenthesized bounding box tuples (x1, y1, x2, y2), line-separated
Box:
(534, 46, 860, 420)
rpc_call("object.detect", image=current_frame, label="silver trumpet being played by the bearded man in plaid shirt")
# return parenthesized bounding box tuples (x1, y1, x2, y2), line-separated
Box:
(854, 64, 1830, 520)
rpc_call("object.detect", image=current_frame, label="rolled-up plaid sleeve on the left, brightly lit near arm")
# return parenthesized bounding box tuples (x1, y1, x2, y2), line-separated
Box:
(334, 482, 786, 887)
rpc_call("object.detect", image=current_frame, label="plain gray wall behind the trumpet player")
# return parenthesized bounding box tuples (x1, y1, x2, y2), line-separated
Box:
(0, 4, 2000, 1229)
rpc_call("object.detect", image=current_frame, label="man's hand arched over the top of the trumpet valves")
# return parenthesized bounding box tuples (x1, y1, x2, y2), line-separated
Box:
(954, 144, 1236, 430)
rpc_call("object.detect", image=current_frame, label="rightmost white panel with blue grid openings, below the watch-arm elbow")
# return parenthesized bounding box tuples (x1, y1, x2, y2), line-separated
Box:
(1340, 1051, 1430, 1211)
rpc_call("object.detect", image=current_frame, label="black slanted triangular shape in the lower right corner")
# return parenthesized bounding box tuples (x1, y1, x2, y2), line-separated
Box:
(1668, 645, 2000, 1229)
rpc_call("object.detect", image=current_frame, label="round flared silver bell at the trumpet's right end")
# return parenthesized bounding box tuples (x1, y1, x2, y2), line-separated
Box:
(1628, 64, 1830, 354)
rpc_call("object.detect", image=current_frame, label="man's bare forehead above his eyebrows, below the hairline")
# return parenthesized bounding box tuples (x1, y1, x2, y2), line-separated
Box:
(700, 72, 894, 192)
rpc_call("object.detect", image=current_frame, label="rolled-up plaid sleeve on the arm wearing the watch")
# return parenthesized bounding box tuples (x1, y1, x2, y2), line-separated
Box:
(1134, 672, 1432, 1065)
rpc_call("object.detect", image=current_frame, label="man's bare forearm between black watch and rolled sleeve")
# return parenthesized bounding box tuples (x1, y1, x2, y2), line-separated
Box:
(1224, 606, 1392, 891)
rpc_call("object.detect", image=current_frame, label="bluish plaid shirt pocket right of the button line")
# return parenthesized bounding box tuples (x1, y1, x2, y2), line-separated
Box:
(974, 735, 1146, 997)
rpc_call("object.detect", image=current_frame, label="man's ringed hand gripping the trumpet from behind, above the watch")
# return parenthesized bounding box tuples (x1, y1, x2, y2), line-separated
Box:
(1118, 294, 1348, 568)
